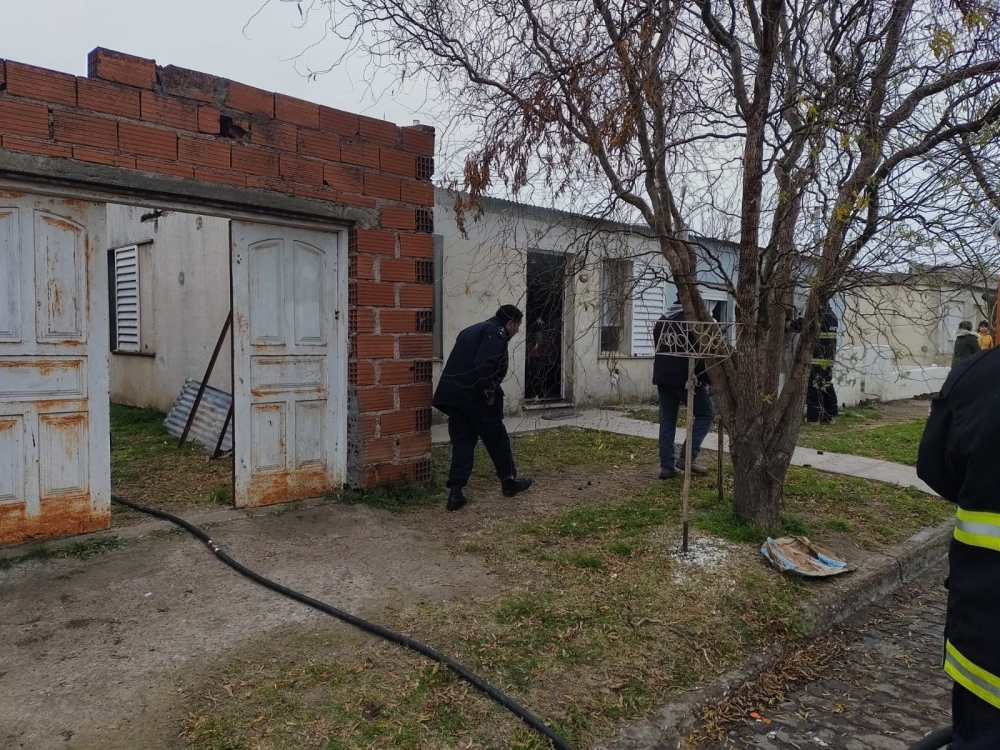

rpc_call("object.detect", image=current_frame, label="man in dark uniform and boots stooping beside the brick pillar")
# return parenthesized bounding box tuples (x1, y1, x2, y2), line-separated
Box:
(434, 305, 531, 510)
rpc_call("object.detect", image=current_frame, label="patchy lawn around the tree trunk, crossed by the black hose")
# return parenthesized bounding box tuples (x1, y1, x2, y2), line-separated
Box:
(176, 428, 948, 750)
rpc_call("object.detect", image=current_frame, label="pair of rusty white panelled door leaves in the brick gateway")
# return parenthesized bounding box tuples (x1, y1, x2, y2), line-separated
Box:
(0, 192, 347, 545)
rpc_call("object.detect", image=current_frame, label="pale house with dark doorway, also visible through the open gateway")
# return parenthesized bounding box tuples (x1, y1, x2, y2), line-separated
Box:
(107, 190, 736, 414)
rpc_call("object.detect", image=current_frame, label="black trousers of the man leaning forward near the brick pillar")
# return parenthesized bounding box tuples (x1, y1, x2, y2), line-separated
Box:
(438, 399, 517, 487)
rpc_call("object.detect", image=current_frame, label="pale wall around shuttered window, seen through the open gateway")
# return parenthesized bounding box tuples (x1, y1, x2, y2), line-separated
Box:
(107, 205, 232, 411)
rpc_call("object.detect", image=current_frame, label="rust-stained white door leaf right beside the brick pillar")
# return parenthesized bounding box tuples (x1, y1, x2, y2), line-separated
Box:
(230, 221, 347, 507)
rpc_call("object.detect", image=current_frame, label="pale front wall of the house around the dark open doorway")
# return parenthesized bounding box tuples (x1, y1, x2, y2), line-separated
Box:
(434, 190, 736, 414)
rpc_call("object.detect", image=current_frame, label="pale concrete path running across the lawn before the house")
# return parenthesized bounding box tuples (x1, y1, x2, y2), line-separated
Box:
(431, 409, 935, 494)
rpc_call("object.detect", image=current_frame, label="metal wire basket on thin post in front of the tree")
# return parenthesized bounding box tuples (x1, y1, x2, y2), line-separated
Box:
(656, 319, 736, 553)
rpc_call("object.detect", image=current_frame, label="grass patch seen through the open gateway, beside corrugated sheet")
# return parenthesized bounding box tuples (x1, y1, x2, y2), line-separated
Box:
(111, 404, 233, 525)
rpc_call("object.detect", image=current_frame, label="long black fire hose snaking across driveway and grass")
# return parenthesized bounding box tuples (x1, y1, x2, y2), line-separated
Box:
(111, 495, 575, 750)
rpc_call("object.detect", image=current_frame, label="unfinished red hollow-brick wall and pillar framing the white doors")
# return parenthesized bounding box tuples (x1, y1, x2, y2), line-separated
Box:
(0, 49, 434, 486)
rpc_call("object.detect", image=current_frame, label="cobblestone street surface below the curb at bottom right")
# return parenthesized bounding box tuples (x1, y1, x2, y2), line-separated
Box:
(700, 564, 951, 750)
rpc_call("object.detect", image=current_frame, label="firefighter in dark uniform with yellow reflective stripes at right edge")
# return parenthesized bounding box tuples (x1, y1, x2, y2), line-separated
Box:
(917, 349, 1000, 750)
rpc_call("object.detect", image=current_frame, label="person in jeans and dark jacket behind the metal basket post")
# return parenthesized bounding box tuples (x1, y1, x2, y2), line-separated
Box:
(653, 300, 715, 479)
